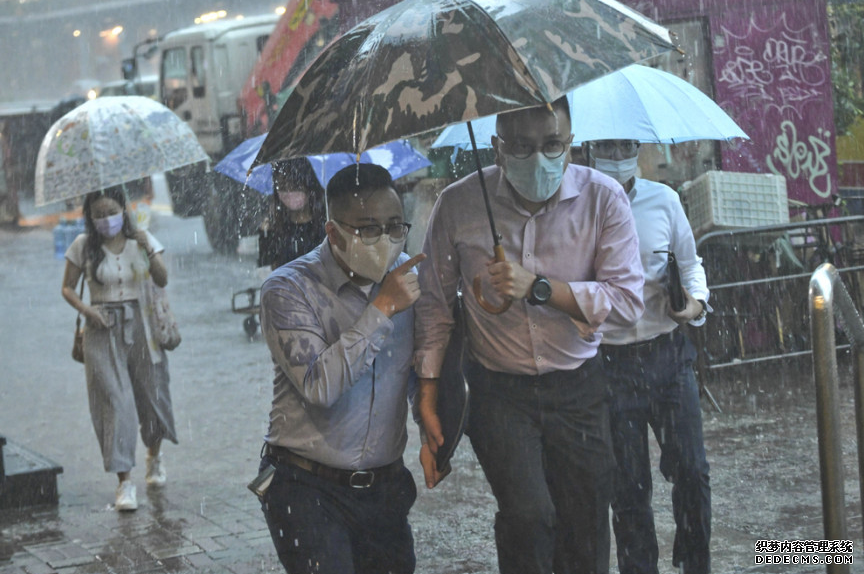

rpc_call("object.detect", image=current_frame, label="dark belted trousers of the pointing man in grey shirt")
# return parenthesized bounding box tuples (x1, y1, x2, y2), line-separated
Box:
(261, 456, 417, 574)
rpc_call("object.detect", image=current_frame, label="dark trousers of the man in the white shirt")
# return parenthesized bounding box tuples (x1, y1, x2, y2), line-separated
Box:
(601, 331, 711, 574)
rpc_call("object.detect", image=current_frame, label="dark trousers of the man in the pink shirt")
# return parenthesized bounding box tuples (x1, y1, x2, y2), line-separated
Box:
(466, 359, 613, 574)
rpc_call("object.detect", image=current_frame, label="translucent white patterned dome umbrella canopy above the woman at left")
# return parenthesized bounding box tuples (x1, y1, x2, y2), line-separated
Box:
(36, 96, 210, 206)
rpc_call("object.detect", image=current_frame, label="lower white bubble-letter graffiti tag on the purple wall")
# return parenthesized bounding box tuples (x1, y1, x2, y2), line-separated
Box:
(765, 120, 831, 197)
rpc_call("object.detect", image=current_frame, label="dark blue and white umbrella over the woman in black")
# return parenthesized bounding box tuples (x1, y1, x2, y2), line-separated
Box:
(214, 134, 432, 195)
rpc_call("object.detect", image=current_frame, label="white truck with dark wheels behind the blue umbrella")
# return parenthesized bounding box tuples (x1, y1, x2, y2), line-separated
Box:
(124, 14, 280, 252)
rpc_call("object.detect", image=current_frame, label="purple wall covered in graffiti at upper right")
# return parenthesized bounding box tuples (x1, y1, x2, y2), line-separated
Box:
(629, 0, 837, 204)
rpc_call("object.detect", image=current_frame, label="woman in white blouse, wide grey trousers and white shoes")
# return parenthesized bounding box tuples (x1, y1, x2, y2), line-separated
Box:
(62, 186, 177, 510)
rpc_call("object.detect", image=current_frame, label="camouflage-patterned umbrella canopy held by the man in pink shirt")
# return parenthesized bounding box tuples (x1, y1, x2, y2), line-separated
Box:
(255, 0, 673, 164)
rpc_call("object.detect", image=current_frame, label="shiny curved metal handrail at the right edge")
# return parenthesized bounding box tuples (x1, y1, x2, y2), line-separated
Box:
(809, 263, 864, 574)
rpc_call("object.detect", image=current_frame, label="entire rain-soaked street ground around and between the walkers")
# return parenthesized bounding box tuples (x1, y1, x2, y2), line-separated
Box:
(0, 201, 864, 574)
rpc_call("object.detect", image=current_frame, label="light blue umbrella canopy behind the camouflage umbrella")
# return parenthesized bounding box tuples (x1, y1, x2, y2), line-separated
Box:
(432, 64, 750, 148)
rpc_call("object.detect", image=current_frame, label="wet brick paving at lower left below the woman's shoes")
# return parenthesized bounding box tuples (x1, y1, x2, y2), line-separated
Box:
(0, 485, 282, 574)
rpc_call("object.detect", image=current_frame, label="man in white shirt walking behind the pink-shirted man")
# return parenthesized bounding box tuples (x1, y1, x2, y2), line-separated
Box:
(583, 140, 711, 574)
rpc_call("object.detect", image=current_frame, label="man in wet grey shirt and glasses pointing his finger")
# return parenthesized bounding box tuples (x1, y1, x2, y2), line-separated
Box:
(261, 164, 425, 574)
